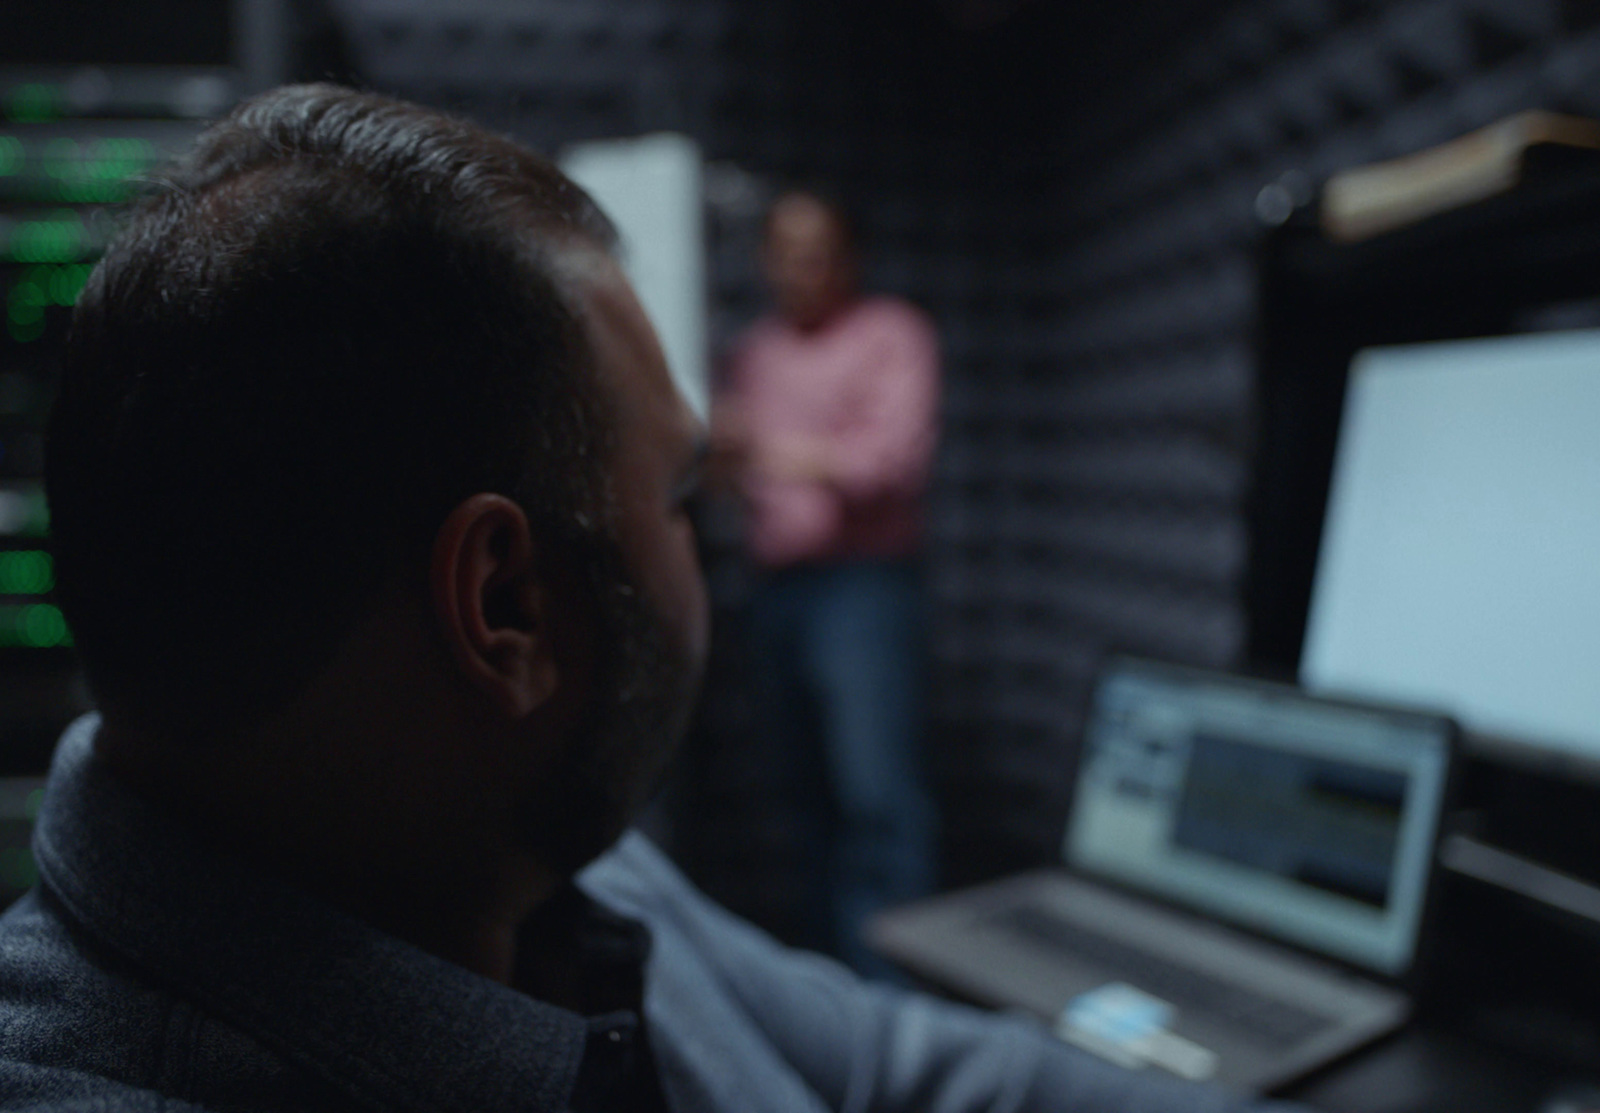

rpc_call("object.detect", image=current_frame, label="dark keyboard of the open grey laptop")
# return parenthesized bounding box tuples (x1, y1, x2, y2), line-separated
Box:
(989, 905, 1330, 1049)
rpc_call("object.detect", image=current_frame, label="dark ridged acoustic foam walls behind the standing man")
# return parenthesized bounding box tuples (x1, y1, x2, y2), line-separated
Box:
(12, 0, 1600, 929)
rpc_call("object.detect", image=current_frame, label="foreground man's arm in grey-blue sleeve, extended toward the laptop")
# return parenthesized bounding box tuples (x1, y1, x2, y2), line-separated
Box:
(586, 836, 1286, 1113)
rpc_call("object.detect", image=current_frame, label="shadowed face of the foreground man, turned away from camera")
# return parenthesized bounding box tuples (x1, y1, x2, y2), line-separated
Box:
(528, 249, 706, 875)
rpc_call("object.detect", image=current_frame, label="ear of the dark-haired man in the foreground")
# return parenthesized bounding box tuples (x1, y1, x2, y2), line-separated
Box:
(429, 494, 560, 718)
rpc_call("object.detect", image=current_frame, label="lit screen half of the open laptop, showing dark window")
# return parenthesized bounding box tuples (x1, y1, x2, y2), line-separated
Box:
(1066, 660, 1453, 975)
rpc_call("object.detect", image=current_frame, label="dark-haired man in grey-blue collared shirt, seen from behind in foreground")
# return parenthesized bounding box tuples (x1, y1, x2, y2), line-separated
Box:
(0, 86, 1286, 1113)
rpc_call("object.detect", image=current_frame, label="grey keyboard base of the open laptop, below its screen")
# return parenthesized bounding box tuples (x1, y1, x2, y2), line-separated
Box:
(867, 870, 1408, 1094)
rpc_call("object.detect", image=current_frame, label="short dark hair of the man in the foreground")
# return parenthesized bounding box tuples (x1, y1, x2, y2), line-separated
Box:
(46, 86, 614, 736)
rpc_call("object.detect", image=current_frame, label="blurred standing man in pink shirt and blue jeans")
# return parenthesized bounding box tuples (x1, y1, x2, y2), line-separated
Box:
(715, 192, 939, 972)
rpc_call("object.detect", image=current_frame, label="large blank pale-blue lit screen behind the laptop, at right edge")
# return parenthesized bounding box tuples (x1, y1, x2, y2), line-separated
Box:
(1301, 329, 1600, 761)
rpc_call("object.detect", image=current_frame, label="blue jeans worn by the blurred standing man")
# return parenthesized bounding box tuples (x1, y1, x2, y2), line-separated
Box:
(749, 561, 933, 975)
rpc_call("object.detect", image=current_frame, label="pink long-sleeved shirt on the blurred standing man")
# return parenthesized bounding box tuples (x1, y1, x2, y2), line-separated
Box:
(726, 297, 939, 568)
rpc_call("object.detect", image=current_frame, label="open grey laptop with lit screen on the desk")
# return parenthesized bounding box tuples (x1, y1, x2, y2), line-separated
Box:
(867, 659, 1454, 1092)
